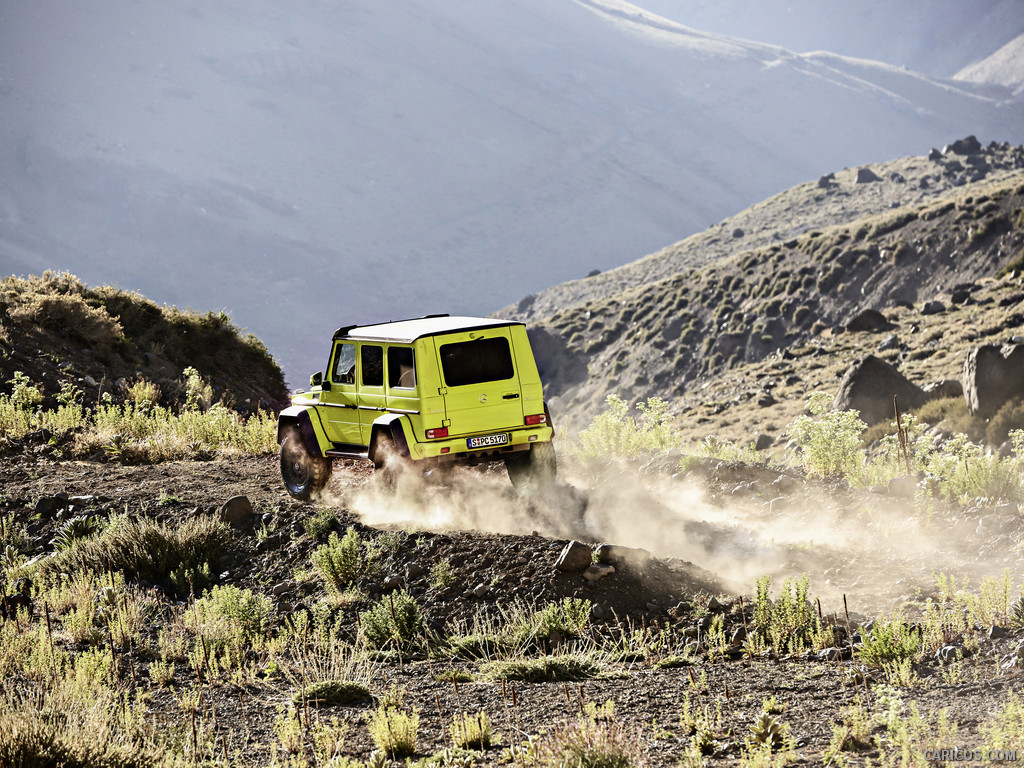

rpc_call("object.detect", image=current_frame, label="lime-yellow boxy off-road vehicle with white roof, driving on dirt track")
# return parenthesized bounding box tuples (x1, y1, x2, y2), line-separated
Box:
(278, 314, 556, 499)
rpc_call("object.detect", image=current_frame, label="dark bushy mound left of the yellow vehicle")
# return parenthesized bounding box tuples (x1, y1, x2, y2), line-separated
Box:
(0, 272, 288, 413)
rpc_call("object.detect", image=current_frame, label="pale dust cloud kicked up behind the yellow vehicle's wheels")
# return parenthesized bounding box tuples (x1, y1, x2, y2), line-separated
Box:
(334, 457, 1021, 612)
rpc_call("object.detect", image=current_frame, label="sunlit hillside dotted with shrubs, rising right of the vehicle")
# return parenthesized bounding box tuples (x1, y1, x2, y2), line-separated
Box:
(509, 145, 1024, 430)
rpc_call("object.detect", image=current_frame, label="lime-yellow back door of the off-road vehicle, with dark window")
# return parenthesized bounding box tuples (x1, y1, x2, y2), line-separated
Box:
(434, 328, 522, 444)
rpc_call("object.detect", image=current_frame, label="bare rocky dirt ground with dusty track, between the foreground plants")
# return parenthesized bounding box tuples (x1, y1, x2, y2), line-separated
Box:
(6, 445, 1024, 765)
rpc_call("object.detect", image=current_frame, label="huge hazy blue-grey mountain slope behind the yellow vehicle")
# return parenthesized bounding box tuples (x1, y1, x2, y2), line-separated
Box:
(6, 0, 1024, 381)
